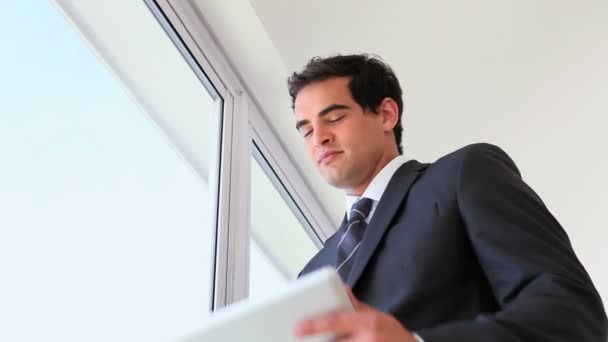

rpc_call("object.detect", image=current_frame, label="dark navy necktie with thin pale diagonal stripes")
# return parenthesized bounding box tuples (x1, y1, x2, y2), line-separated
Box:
(336, 197, 374, 282)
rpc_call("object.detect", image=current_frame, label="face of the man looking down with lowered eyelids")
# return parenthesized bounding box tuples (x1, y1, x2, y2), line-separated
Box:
(294, 77, 398, 195)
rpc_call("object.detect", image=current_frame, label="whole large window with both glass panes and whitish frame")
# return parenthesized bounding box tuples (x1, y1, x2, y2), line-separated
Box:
(0, 0, 333, 341)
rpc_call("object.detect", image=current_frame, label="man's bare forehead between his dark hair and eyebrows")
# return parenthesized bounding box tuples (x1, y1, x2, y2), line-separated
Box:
(294, 77, 354, 118)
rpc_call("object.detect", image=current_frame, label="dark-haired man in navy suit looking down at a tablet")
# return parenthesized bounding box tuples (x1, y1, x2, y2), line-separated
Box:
(289, 55, 607, 342)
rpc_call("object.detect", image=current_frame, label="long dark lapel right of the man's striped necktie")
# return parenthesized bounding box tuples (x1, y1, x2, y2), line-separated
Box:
(342, 160, 426, 288)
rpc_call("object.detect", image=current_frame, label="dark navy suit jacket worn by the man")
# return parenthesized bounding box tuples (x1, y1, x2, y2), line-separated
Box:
(301, 144, 608, 342)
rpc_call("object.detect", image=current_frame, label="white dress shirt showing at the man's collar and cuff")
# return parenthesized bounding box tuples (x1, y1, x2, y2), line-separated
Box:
(346, 155, 424, 342)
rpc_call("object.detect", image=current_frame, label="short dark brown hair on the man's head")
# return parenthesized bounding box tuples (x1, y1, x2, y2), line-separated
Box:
(287, 54, 403, 154)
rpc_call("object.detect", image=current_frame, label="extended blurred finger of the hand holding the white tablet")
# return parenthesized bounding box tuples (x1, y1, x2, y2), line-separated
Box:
(294, 311, 361, 337)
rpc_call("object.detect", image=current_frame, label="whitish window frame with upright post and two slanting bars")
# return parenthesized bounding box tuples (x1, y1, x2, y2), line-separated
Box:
(150, 0, 334, 309)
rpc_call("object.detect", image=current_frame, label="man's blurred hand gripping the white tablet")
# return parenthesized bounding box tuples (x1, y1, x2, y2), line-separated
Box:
(294, 287, 417, 342)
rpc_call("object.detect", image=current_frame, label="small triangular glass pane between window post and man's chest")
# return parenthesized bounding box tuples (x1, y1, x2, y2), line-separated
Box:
(249, 158, 318, 298)
